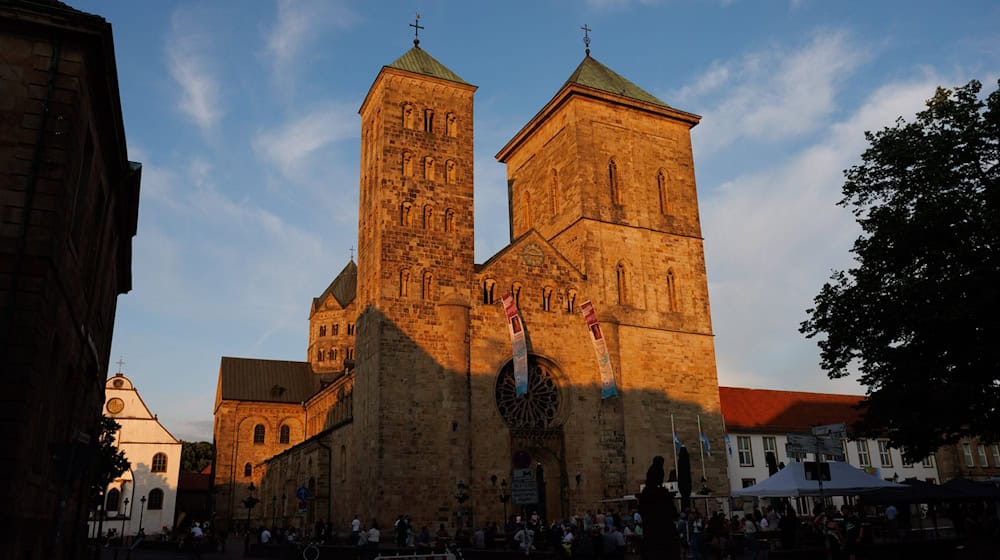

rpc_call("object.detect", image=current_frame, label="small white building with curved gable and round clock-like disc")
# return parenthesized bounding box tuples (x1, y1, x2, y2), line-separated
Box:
(90, 373, 181, 536)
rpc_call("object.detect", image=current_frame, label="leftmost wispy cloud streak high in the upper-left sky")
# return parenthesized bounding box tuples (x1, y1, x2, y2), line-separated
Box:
(167, 12, 223, 132)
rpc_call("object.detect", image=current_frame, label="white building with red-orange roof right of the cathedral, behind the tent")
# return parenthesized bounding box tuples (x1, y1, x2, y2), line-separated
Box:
(719, 387, 947, 514)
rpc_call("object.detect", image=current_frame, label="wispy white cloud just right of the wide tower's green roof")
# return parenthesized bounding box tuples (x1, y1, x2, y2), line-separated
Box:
(664, 31, 865, 155)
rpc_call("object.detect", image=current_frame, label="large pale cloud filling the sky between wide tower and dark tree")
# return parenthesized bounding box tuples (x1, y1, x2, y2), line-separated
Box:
(703, 76, 940, 393)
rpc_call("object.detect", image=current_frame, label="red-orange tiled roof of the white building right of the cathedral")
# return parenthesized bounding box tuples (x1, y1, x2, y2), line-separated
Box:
(719, 387, 864, 434)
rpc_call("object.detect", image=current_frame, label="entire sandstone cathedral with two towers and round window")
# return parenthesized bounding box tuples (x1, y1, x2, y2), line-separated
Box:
(213, 42, 728, 531)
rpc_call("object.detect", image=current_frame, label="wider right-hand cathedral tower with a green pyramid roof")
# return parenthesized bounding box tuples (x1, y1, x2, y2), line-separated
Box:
(497, 52, 725, 493)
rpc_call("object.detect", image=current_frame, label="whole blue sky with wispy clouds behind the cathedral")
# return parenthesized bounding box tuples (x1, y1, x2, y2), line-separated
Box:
(80, 0, 1000, 440)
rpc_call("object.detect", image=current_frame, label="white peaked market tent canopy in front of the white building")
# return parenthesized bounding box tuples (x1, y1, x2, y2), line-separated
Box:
(733, 461, 902, 498)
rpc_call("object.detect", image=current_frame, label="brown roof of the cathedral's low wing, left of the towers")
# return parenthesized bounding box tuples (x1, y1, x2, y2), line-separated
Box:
(219, 356, 320, 403)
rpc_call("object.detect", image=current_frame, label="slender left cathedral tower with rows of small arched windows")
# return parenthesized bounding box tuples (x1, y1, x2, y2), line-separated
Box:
(354, 45, 476, 512)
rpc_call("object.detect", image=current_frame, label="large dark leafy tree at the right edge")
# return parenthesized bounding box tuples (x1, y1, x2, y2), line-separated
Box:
(800, 77, 1000, 460)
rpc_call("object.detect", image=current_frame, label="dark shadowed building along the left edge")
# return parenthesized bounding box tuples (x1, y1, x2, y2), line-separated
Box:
(0, 0, 141, 560)
